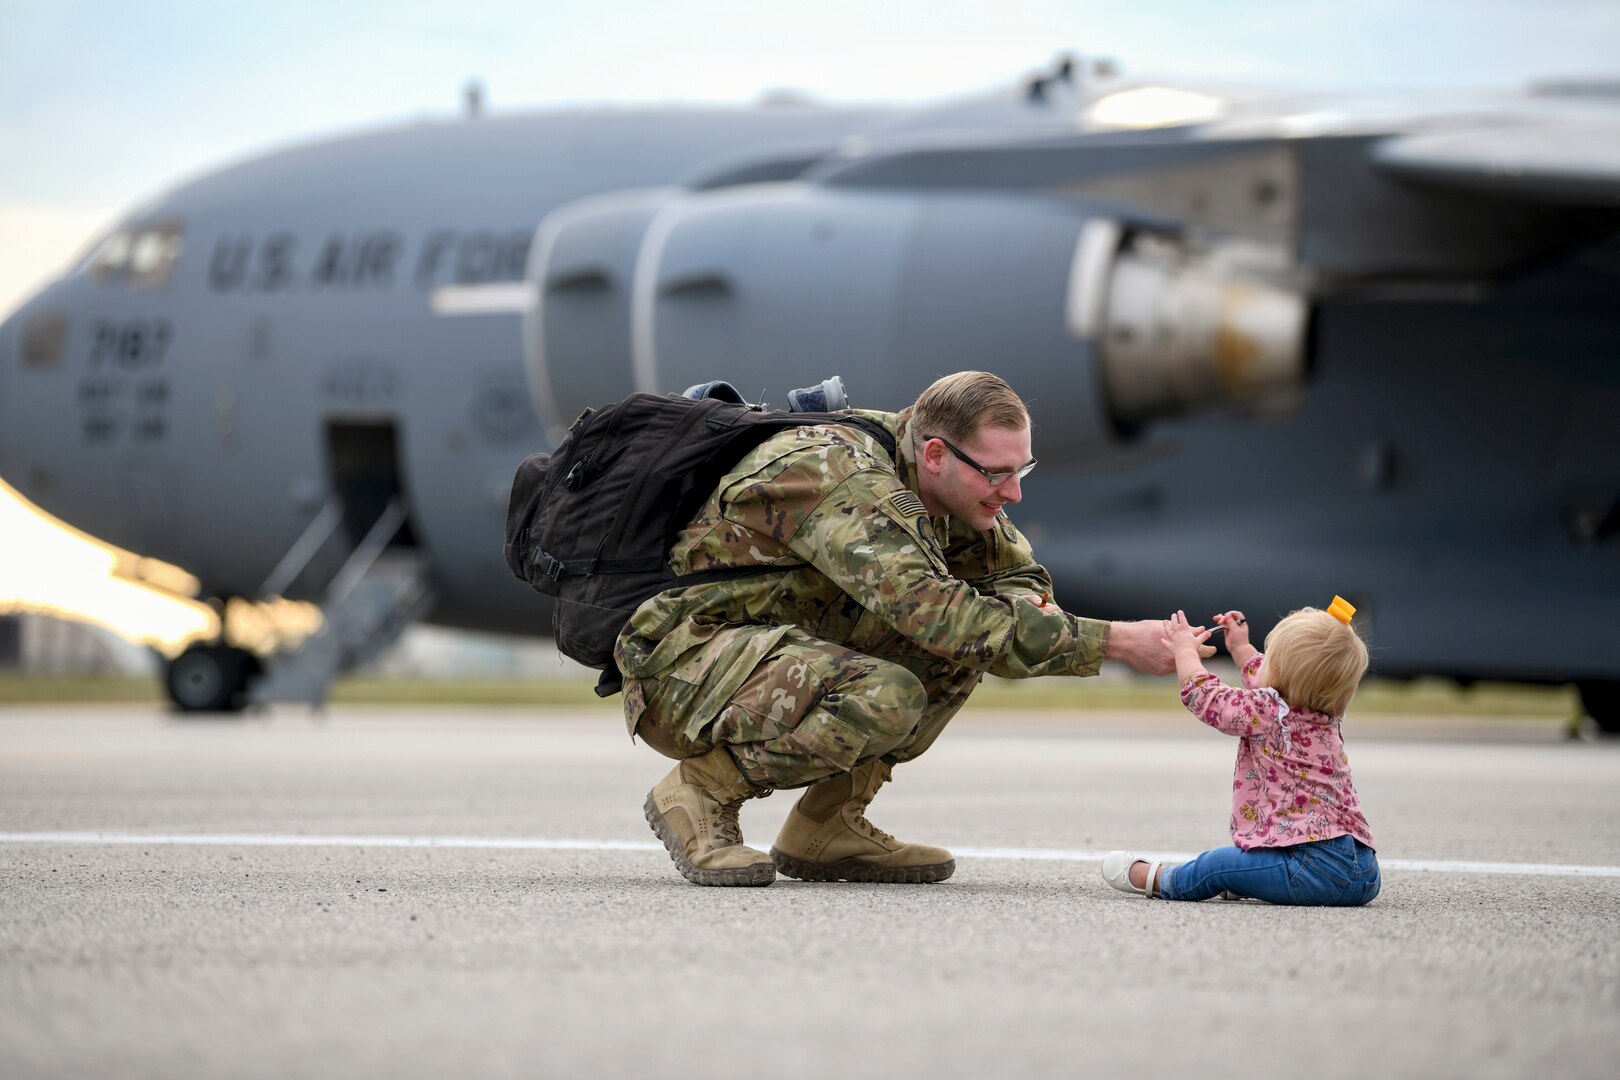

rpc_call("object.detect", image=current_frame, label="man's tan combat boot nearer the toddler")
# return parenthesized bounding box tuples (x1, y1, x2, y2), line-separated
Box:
(771, 759, 956, 882)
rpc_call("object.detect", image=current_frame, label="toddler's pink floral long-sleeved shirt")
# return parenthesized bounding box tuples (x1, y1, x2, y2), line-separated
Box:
(1181, 654, 1372, 852)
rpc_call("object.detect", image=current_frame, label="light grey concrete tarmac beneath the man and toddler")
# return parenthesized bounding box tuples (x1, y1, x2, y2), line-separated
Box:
(0, 706, 1620, 1080)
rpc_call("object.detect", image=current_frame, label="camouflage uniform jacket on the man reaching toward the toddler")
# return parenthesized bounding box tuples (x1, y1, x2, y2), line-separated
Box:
(617, 413, 1108, 732)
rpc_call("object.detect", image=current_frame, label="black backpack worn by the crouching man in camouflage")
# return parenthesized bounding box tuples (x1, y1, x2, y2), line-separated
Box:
(505, 393, 894, 696)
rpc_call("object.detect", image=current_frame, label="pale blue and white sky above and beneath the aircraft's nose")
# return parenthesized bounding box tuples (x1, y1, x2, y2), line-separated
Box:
(0, 0, 1620, 635)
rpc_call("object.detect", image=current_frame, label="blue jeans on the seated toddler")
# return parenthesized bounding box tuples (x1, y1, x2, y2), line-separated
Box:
(1158, 836, 1379, 907)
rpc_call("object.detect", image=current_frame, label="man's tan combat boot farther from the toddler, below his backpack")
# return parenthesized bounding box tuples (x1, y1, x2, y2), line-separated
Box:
(646, 746, 776, 886)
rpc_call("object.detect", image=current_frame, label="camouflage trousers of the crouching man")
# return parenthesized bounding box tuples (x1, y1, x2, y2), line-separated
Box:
(627, 628, 980, 789)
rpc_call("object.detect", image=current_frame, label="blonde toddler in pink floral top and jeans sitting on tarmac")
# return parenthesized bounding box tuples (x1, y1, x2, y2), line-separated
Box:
(1103, 596, 1379, 907)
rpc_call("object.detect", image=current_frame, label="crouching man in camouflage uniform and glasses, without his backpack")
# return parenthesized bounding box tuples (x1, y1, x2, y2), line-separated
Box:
(616, 372, 1192, 884)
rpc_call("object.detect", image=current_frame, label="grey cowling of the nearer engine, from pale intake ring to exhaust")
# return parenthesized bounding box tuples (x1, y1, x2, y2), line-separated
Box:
(632, 183, 1111, 455)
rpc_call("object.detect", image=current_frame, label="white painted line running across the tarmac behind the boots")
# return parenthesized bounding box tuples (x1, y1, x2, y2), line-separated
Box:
(0, 832, 1620, 878)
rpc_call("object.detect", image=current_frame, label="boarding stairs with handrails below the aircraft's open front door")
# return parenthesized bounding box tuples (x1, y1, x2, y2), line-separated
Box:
(248, 497, 434, 708)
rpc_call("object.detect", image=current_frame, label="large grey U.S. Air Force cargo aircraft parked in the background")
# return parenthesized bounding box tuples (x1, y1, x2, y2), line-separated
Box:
(0, 58, 1620, 730)
